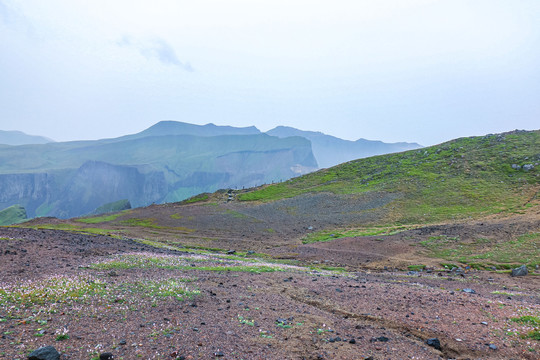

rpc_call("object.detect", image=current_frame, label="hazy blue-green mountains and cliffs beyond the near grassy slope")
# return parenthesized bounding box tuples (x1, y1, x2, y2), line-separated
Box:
(0, 121, 419, 218)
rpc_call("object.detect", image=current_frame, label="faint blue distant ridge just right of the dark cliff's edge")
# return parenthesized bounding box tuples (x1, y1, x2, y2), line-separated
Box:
(266, 126, 422, 168)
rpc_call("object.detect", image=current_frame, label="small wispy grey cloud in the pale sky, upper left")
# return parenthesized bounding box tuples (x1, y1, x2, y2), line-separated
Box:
(116, 36, 193, 72)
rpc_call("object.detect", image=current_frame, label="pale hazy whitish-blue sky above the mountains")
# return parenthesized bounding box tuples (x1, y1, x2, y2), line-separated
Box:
(0, 0, 540, 146)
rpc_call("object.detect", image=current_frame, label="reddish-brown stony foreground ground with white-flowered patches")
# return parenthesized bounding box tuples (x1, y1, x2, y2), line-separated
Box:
(0, 226, 540, 360)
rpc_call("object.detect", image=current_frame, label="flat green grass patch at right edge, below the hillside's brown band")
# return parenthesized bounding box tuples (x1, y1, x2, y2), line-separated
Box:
(420, 233, 540, 269)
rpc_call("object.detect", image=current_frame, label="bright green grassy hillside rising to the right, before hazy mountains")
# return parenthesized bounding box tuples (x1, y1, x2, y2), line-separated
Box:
(238, 131, 540, 223)
